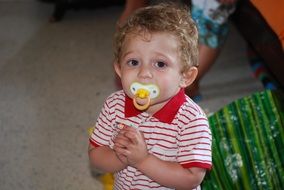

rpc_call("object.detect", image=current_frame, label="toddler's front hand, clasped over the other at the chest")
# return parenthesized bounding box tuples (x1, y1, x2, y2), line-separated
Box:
(119, 127, 148, 167)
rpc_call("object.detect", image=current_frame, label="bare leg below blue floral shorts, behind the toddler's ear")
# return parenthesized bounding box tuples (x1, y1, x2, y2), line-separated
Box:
(186, 44, 220, 97)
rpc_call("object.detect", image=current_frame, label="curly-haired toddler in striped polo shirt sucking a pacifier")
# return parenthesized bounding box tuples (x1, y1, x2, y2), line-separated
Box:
(89, 4, 211, 190)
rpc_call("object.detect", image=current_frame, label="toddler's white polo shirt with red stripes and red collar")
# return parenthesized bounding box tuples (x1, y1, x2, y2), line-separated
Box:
(90, 89, 212, 190)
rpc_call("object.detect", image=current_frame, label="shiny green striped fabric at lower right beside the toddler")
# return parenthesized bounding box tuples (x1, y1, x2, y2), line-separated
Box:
(202, 91, 284, 190)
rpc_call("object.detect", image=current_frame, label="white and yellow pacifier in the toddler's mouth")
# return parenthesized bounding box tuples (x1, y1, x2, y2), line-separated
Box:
(130, 82, 160, 110)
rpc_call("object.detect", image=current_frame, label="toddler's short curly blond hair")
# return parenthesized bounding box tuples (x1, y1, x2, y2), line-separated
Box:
(114, 3, 198, 72)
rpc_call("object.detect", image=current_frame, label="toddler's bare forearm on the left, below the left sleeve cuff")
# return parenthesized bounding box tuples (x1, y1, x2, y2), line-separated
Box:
(88, 143, 126, 172)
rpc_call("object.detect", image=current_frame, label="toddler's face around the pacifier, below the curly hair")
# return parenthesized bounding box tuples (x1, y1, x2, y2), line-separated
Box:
(115, 33, 189, 113)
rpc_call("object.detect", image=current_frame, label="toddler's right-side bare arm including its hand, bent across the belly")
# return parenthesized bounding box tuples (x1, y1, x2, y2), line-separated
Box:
(115, 127, 206, 189)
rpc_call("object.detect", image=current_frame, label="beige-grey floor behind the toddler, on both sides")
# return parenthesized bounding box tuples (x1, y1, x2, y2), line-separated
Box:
(0, 0, 262, 190)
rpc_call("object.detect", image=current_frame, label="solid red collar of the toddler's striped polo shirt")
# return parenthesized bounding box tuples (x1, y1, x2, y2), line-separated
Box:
(124, 89, 185, 123)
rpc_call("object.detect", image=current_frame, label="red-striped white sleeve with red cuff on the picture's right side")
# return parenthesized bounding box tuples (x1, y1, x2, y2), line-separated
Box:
(177, 114, 212, 169)
